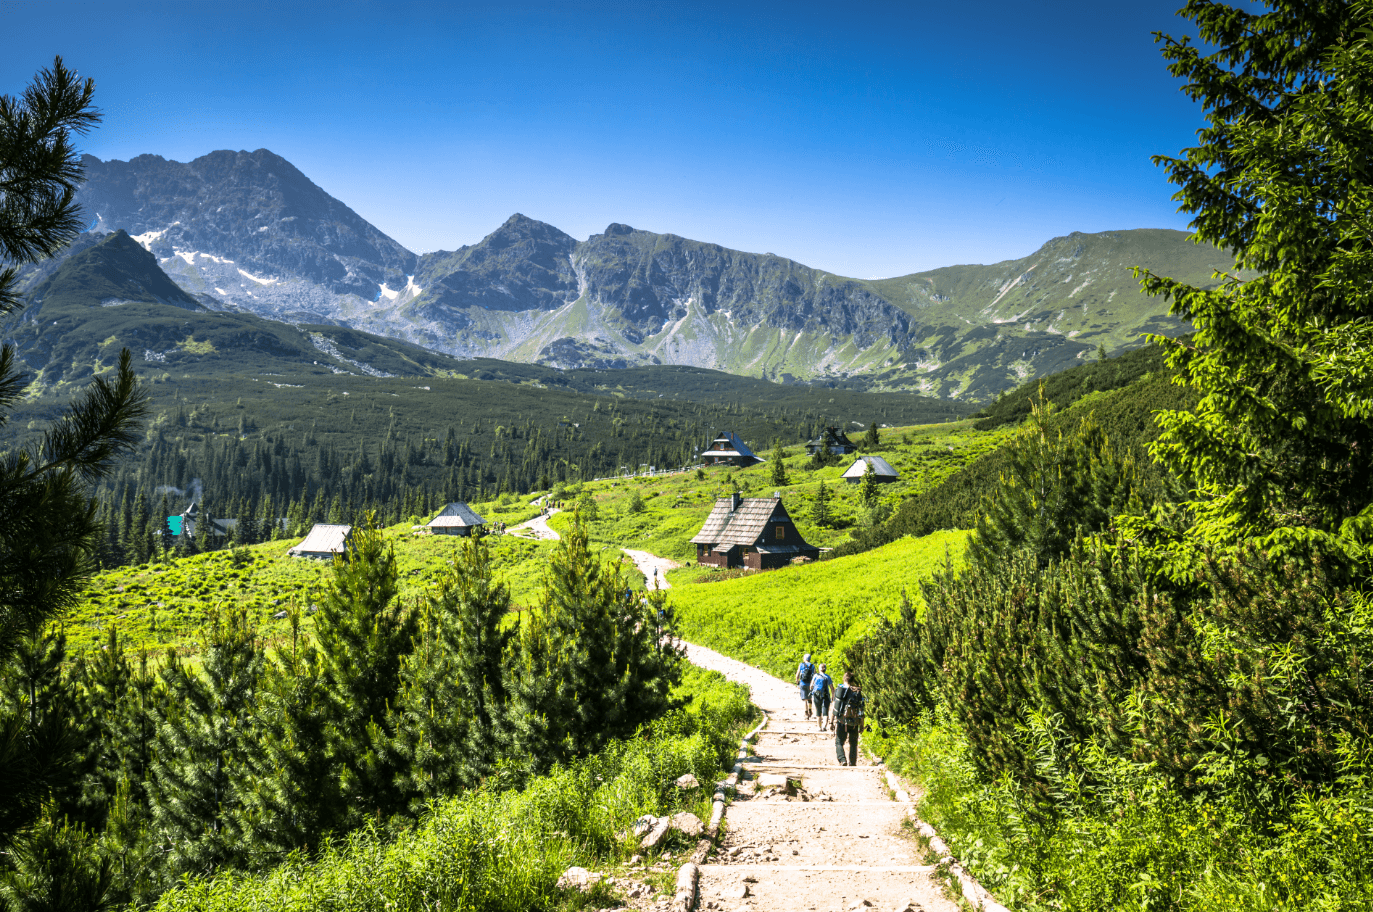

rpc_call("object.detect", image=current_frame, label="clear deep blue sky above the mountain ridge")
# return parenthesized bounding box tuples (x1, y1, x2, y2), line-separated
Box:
(0, 0, 1200, 277)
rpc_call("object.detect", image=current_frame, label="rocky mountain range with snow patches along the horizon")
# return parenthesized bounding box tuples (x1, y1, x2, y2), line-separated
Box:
(21, 150, 1229, 400)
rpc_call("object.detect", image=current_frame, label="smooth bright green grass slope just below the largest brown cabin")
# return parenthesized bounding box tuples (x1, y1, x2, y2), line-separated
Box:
(667, 532, 968, 680)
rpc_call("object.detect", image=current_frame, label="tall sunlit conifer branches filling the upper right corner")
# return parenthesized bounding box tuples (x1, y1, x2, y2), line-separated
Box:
(1142, 0, 1373, 551)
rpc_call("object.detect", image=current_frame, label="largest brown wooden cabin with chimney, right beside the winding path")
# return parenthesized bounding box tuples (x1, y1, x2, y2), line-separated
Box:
(692, 494, 820, 570)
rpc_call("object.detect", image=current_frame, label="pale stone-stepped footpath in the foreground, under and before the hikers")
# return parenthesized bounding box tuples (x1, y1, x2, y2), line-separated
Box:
(681, 640, 958, 912)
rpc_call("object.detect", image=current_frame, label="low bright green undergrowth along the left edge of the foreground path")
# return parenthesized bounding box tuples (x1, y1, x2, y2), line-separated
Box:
(147, 670, 750, 912)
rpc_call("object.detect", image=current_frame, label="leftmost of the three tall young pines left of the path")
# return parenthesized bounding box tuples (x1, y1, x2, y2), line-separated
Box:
(314, 521, 417, 825)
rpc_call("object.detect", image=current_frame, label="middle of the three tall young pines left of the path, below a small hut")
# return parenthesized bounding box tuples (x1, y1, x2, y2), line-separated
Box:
(400, 538, 514, 810)
